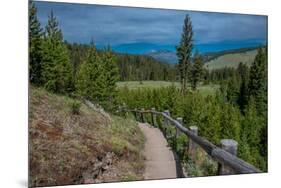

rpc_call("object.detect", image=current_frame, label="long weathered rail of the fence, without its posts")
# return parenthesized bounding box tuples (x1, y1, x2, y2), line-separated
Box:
(123, 109, 261, 174)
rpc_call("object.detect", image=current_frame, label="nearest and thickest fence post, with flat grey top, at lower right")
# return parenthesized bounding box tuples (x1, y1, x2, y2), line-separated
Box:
(218, 139, 238, 175)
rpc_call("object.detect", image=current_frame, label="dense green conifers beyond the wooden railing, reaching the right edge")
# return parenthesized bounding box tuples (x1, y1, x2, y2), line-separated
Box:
(118, 46, 267, 171)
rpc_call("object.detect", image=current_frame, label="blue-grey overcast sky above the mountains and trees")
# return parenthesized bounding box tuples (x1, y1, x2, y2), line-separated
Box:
(36, 2, 267, 52)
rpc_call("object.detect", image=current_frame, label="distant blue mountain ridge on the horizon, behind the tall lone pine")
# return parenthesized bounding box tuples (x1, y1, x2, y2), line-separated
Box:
(108, 42, 265, 67)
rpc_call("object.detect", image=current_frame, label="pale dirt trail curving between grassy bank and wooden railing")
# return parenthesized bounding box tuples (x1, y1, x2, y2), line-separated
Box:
(139, 123, 177, 179)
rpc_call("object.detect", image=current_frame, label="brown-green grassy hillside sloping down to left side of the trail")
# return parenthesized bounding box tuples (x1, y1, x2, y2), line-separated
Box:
(29, 87, 144, 186)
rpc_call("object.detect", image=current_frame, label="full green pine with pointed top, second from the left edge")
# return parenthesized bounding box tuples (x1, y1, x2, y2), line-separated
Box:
(42, 11, 71, 93)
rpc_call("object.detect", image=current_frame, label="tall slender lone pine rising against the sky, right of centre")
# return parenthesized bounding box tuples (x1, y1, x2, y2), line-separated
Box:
(177, 15, 193, 93)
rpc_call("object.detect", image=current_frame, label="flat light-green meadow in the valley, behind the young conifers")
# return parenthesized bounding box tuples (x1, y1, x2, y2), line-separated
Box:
(117, 81, 219, 96)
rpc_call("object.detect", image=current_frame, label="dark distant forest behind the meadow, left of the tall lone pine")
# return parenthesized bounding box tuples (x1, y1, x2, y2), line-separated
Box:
(66, 42, 177, 81)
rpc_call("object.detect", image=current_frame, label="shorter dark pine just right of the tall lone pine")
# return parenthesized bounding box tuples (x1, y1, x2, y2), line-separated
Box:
(189, 52, 203, 90)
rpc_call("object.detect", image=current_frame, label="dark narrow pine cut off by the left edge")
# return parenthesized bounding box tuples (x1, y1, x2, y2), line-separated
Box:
(29, 2, 43, 85)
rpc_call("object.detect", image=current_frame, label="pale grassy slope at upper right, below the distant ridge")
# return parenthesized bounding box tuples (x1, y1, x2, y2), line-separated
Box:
(202, 49, 257, 70)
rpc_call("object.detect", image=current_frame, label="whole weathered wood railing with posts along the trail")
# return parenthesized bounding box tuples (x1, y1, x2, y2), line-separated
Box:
(123, 108, 261, 175)
